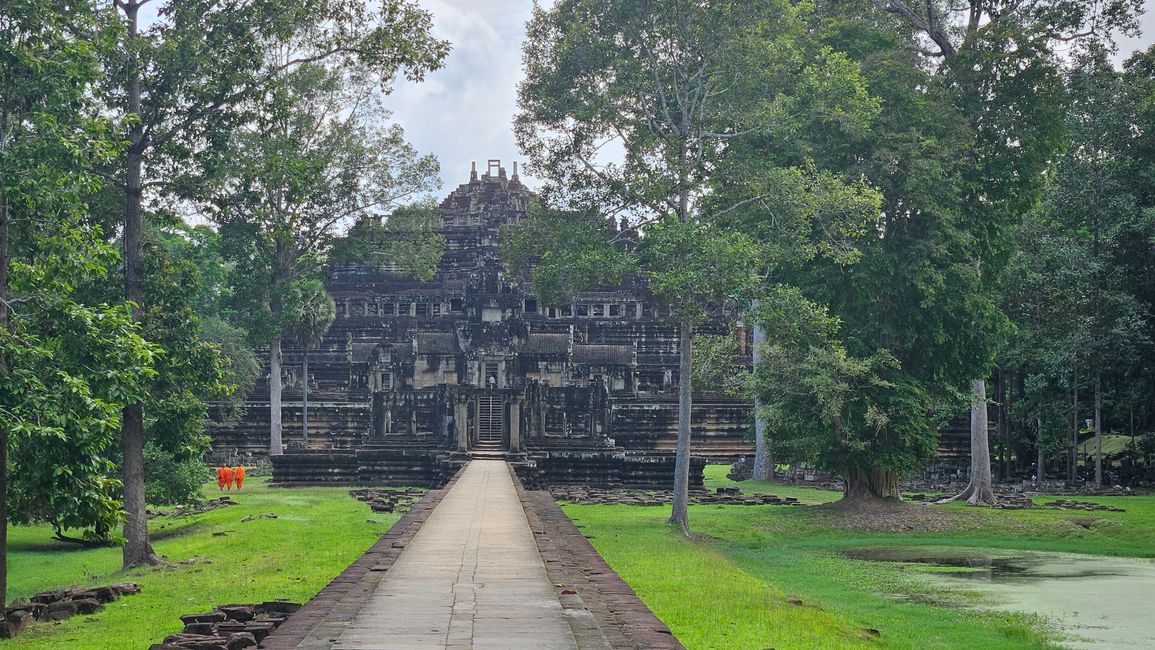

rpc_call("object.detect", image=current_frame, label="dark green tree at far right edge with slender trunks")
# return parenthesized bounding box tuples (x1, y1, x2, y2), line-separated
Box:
(1004, 44, 1155, 487)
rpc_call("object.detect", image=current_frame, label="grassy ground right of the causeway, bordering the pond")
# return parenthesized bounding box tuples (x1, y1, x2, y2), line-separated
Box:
(565, 466, 1155, 650)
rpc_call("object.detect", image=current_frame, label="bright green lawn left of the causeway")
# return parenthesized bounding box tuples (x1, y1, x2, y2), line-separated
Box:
(3, 477, 400, 650)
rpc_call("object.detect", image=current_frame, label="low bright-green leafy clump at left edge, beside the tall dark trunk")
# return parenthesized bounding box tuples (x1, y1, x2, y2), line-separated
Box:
(0, 298, 157, 541)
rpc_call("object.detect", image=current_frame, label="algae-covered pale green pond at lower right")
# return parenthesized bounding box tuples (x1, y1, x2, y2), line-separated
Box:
(847, 546, 1155, 650)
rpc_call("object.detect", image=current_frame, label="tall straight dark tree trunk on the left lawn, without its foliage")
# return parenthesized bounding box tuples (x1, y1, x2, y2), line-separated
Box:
(120, 3, 162, 569)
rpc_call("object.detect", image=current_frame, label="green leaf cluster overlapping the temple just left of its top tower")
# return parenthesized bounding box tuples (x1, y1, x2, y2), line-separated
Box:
(328, 201, 445, 282)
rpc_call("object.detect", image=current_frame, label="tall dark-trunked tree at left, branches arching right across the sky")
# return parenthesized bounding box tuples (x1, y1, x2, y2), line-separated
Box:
(106, 0, 448, 568)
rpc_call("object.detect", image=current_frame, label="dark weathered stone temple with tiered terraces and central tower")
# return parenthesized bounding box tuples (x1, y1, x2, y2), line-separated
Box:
(211, 160, 752, 487)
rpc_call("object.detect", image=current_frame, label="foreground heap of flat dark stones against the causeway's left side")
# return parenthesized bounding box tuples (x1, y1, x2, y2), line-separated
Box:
(149, 600, 300, 650)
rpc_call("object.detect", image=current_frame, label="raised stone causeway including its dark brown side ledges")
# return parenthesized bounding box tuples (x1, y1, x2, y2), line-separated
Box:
(261, 460, 680, 650)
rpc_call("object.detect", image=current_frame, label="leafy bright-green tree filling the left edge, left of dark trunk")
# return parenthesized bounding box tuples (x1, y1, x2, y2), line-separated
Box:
(0, 0, 148, 603)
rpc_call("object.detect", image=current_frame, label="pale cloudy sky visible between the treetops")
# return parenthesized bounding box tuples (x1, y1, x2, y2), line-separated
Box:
(386, 0, 1155, 195)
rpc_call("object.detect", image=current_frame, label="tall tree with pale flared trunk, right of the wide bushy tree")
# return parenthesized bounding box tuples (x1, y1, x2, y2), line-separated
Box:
(872, 0, 1140, 503)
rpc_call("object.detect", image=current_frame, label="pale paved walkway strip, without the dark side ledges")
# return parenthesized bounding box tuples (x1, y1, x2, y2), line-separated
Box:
(299, 460, 609, 650)
